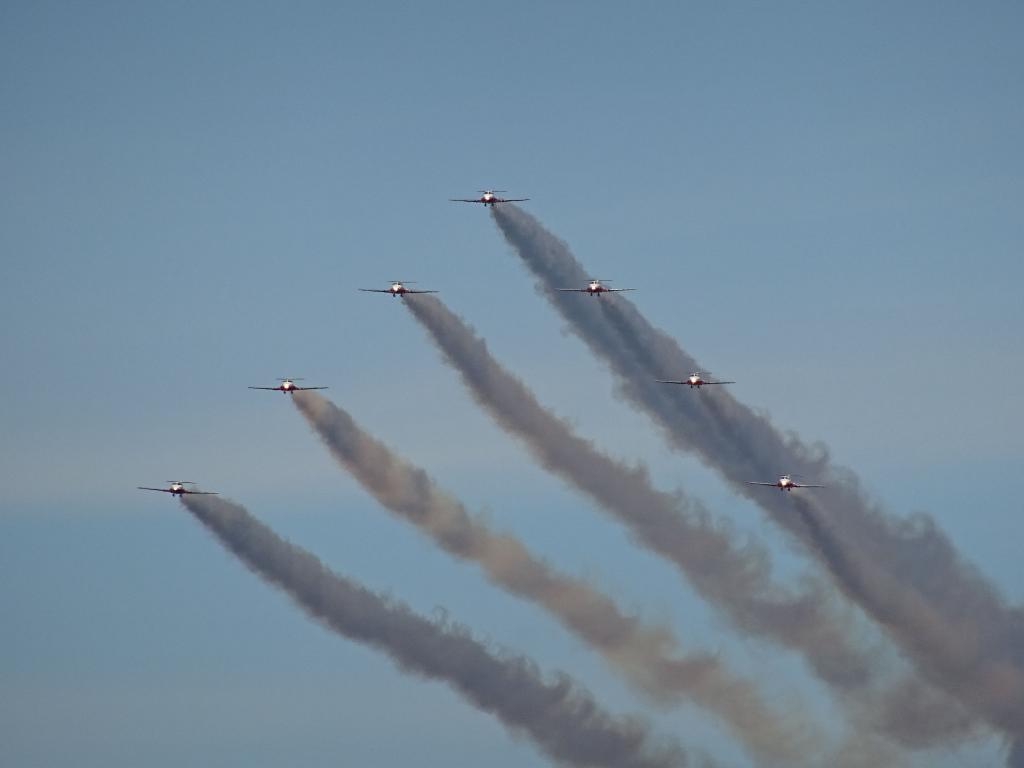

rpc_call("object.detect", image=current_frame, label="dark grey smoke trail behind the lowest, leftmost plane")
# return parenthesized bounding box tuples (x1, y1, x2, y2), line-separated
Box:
(181, 496, 687, 768)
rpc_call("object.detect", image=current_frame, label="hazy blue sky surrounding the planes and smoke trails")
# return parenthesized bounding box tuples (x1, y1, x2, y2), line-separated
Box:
(0, 2, 1024, 768)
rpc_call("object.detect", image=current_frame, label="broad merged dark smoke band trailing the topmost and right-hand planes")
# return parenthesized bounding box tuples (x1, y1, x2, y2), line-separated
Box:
(492, 206, 1024, 753)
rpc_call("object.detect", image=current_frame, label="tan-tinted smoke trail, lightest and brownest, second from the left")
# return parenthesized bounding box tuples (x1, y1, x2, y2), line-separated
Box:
(293, 393, 822, 765)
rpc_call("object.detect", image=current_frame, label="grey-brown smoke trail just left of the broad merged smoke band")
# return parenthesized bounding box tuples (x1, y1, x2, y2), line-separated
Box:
(399, 297, 936, 765)
